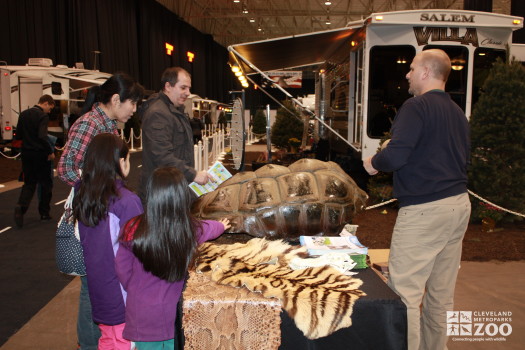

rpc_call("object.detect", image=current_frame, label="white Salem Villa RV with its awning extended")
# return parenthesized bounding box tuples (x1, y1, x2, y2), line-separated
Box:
(228, 10, 523, 158)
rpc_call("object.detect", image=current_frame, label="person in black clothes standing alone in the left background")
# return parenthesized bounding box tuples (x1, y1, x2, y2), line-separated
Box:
(14, 95, 55, 228)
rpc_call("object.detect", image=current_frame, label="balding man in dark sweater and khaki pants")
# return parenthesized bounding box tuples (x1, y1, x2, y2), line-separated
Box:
(363, 49, 470, 350)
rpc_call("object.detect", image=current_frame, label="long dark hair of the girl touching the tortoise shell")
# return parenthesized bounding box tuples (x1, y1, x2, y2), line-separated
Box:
(129, 167, 200, 282)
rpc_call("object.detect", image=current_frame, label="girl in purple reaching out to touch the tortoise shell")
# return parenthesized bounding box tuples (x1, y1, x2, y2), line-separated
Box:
(115, 167, 230, 349)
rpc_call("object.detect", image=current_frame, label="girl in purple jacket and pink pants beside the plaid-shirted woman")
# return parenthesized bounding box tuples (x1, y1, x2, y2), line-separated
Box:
(73, 133, 142, 350)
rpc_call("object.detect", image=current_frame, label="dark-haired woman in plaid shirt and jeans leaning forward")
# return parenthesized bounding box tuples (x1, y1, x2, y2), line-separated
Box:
(57, 73, 144, 350)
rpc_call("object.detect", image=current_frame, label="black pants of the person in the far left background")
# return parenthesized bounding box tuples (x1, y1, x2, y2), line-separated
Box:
(18, 151, 53, 215)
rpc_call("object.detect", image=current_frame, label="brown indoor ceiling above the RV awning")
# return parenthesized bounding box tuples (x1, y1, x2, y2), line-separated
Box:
(156, 0, 463, 47)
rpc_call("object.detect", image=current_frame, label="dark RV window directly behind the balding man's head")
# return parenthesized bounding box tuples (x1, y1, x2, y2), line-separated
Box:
(423, 45, 469, 111)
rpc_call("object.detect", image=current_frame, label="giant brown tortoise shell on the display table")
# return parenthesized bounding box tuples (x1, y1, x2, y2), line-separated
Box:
(193, 158, 368, 240)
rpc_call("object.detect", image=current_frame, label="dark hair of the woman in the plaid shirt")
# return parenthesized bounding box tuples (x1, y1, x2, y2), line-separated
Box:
(82, 73, 144, 114)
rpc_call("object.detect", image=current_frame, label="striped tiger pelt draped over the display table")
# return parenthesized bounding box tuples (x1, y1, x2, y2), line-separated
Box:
(196, 238, 365, 339)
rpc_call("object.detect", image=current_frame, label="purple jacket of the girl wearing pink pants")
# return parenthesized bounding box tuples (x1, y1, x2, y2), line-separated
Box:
(77, 181, 143, 326)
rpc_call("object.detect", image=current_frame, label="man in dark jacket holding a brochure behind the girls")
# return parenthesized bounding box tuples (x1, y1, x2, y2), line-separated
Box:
(139, 67, 212, 200)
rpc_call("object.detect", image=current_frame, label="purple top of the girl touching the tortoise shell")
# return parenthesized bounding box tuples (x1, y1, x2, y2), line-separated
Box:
(115, 220, 224, 342)
